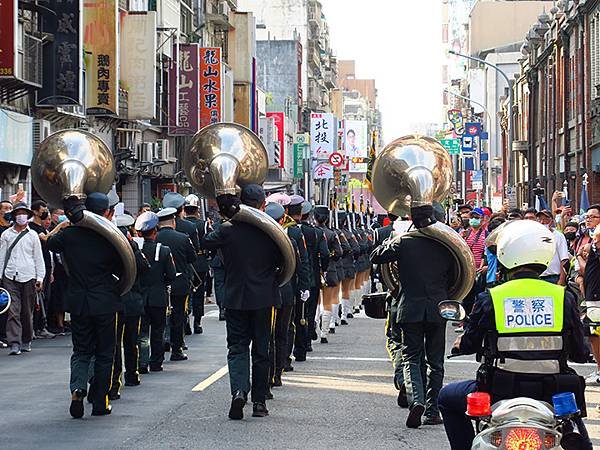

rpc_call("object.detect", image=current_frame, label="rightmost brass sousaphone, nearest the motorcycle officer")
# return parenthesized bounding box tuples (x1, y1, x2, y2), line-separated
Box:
(372, 135, 475, 301)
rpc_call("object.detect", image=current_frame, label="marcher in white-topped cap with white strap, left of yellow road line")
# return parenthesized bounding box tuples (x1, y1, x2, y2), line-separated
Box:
(135, 211, 176, 373)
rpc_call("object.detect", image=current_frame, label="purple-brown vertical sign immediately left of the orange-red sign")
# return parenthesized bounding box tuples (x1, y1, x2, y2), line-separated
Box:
(169, 44, 200, 136)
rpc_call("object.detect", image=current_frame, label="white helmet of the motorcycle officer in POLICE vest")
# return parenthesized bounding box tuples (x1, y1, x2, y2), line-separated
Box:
(496, 220, 556, 270)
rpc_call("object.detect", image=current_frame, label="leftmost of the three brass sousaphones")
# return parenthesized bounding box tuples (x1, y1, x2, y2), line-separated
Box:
(31, 130, 136, 294)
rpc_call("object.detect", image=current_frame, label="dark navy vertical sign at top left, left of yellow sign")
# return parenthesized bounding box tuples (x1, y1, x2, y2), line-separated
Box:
(37, 0, 83, 105)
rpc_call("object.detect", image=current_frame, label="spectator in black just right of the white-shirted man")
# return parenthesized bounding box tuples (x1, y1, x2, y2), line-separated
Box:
(29, 200, 54, 339)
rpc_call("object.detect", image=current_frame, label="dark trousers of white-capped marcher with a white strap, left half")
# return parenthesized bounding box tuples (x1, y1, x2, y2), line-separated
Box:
(139, 306, 167, 368)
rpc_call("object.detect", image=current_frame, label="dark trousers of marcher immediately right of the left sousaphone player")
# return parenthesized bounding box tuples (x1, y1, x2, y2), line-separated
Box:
(111, 312, 140, 392)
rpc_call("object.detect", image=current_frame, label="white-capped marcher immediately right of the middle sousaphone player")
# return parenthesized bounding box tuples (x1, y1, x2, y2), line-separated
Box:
(286, 195, 312, 364)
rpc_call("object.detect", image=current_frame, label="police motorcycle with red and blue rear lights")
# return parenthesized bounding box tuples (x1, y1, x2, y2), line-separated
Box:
(438, 300, 600, 450)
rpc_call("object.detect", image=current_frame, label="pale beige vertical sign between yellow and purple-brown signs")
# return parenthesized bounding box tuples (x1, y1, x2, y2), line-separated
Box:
(120, 11, 156, 120)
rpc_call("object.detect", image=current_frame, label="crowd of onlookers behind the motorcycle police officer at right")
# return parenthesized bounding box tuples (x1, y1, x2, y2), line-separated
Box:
(449, 192, 600, 384)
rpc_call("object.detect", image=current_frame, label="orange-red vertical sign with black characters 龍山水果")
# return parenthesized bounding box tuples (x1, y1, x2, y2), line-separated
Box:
(200, 47, 222, 128)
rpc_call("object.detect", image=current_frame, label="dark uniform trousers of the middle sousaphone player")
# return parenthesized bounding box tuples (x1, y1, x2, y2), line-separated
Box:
(225, 307, 273, 403)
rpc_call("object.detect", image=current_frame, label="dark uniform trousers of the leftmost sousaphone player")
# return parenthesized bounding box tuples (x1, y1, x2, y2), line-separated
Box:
(70, 313, 116, 409)
